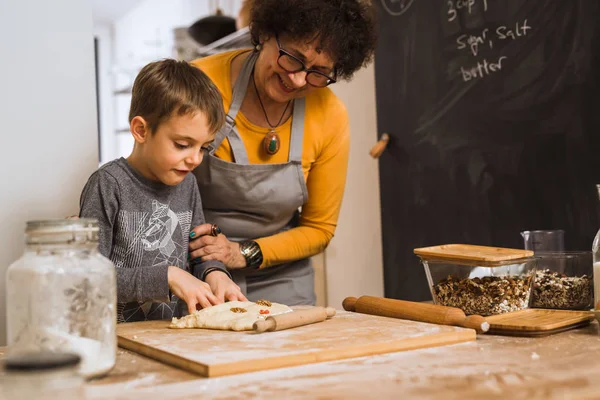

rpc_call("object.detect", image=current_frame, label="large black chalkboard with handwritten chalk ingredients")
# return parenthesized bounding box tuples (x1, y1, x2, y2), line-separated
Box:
(373, 0, 600, 300)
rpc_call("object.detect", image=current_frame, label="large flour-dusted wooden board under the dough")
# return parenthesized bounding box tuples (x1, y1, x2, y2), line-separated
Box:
(117, 311, 476, 377)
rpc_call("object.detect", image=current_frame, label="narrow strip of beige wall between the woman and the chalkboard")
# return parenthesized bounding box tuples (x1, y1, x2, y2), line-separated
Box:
(325, 64, 383, 308)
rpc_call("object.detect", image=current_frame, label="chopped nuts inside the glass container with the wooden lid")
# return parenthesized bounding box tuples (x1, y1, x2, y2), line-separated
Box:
(433, 275, 531, 316)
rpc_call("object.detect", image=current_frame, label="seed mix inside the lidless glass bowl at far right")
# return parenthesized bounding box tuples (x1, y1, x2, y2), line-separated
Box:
(532, 269, 594, 310)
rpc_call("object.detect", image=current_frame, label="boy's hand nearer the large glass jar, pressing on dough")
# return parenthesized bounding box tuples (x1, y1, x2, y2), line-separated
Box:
(168, 265, 221, 314)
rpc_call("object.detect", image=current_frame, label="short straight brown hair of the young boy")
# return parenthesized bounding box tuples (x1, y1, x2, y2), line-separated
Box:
(129, 59, 225, 134)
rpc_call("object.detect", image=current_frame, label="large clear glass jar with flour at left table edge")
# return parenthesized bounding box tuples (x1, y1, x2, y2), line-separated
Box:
(6, 219, 117, 378)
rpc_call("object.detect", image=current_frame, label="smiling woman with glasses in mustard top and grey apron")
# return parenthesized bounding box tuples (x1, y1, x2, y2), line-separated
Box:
(190, 0, 375, 305)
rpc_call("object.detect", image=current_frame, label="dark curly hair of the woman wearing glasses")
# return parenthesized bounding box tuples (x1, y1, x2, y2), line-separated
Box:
(250, 0, 377, 80)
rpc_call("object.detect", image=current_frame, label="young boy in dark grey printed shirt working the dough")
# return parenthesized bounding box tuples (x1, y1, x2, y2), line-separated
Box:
(79, 60, 246, 322)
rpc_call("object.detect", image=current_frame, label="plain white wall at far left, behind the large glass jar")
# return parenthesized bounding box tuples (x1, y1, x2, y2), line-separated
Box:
(0, 0, 98, 345)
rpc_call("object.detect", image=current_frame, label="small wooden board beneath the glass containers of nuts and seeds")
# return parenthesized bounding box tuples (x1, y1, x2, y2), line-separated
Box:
(485, 308, 594, 336)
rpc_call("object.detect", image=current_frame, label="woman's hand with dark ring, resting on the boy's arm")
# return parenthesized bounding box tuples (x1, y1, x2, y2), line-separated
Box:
(189, 224, 246, 269)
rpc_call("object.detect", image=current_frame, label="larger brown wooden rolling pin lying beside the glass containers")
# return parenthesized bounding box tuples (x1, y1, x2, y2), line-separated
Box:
(342, 296, 490, 333)
